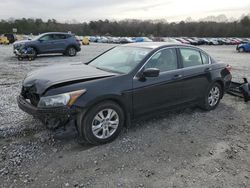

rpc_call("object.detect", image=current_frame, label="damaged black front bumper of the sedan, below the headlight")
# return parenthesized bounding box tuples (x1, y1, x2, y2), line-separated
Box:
(17, 95, 81, 128)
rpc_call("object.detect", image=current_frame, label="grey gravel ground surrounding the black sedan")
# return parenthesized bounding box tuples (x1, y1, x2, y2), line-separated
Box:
(0, 44, 250, 188)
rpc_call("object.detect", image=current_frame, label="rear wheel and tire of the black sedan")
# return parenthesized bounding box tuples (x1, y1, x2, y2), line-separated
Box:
(201, 82, 223, 111)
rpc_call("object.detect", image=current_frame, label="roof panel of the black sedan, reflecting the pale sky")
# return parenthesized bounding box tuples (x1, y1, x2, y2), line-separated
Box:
(122, 42, 194, 49)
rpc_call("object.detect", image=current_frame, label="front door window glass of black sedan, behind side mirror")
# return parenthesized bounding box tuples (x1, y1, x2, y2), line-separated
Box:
(145, 48, 178, 72)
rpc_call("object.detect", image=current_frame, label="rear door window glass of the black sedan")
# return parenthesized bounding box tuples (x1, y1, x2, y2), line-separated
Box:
(180, 48, 202, 67)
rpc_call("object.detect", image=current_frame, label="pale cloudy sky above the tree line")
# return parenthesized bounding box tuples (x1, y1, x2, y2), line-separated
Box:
(0, 0, 250, 22)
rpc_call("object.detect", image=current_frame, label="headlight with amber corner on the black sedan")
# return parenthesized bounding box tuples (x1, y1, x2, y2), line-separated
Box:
(38, 89, 86, 107)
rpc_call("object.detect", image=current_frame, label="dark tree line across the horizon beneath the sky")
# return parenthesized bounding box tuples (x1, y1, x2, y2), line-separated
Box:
(0, 16, 250, 37)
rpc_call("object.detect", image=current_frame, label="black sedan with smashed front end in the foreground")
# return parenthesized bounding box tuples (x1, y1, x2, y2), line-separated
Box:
(17, 42, 232, 144)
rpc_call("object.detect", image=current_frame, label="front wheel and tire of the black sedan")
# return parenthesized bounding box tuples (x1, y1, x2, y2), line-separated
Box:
(77, 101, 125, 145)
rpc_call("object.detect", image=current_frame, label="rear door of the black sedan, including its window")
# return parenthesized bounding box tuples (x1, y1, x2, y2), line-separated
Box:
(179, 47, 212, 102)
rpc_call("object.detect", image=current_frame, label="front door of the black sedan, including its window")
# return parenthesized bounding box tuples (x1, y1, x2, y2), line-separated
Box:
(133, 48, 186, 116)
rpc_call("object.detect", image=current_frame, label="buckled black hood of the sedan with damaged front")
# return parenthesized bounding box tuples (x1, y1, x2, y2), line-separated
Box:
(23, 63, 117, 94)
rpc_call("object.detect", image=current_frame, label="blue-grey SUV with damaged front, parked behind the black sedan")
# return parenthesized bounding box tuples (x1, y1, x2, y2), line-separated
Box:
(13, 32, 81, 56)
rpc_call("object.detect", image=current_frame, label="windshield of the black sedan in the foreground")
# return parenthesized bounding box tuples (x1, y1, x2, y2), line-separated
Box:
(89, 46, 151, 74)
